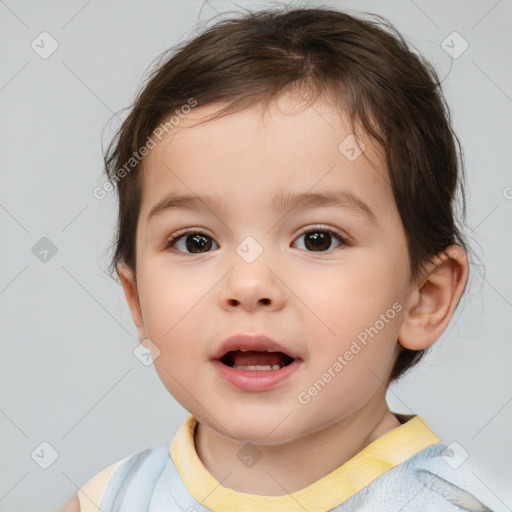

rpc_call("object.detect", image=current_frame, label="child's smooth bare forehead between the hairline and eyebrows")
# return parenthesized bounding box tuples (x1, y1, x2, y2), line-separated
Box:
(141, 94, 393, 220)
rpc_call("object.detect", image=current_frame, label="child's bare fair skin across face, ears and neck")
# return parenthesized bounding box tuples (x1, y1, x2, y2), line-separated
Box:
(61, 90, 467, 506)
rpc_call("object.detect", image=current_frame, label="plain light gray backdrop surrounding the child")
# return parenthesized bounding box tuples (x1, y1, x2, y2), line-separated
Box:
(0, 0, 512, 512)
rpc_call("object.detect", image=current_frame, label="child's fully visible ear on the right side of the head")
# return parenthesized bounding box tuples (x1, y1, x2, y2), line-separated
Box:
(398, 245, 468, 350)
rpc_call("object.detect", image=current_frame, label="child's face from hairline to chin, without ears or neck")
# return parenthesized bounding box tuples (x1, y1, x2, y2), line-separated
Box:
(121, 92, 411, 444)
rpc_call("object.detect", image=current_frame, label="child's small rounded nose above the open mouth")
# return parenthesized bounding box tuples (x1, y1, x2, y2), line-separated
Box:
(218, 245, 286, 311)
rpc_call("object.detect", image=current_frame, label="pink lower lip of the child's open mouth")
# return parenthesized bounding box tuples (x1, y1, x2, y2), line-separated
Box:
(212, 359, 300, 391)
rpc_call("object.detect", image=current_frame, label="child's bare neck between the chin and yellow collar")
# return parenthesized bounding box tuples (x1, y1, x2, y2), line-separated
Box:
(194, 395, 400, 496)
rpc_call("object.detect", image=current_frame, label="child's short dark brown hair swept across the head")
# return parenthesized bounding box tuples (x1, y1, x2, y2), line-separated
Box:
(105, 7, 468, 382)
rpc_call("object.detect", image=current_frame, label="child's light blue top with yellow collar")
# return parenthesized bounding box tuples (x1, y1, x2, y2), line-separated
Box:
(78, 414, 499, 512)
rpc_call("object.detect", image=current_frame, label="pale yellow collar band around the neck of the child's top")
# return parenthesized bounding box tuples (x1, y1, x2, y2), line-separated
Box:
(170, 415, 440, 512)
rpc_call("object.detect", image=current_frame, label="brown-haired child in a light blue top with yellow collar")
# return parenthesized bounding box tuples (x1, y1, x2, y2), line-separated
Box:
(64, 8, 500, 512)
